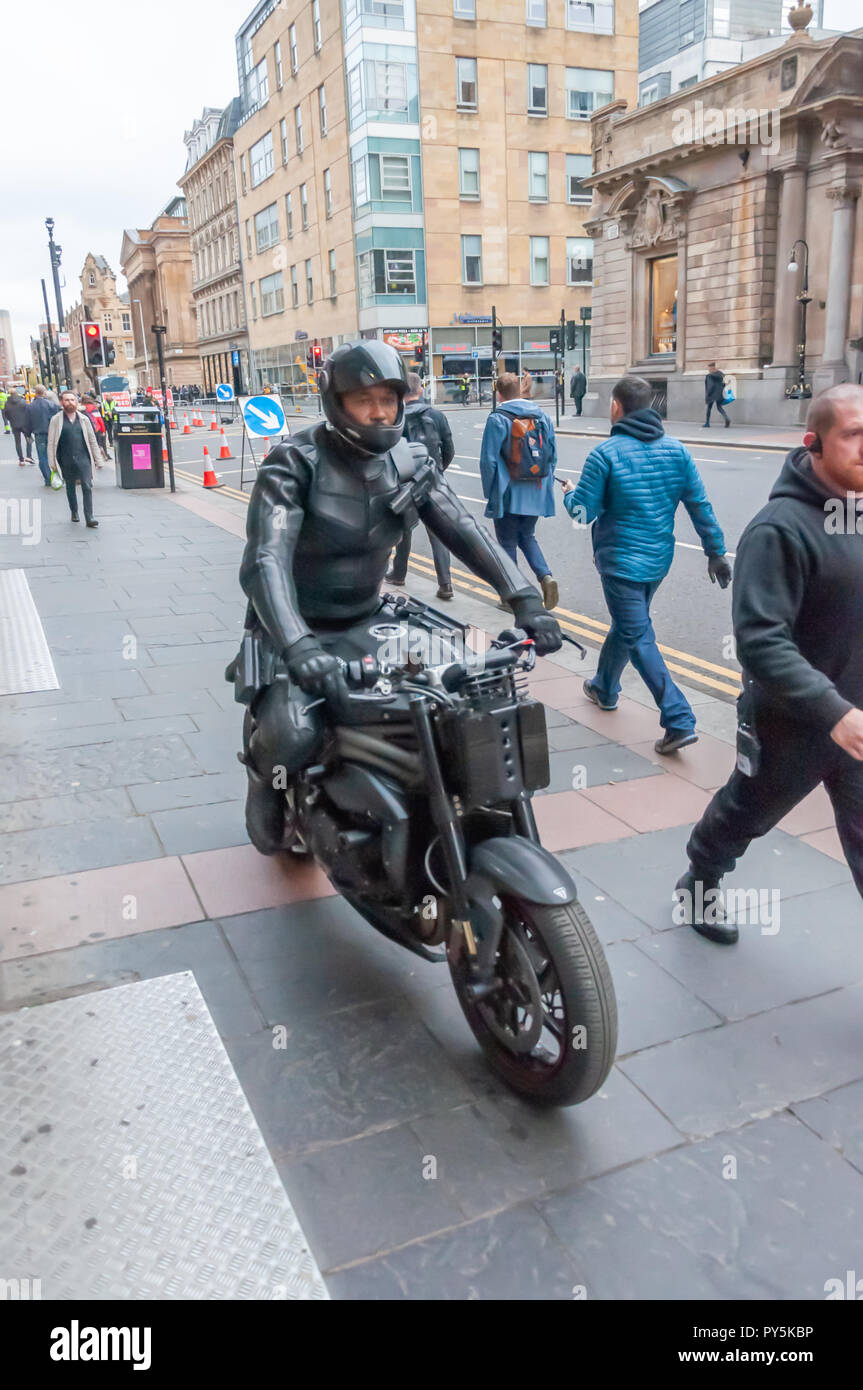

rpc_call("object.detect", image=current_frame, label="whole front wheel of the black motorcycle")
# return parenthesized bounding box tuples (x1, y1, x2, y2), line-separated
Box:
(447, 898, 617, 1105)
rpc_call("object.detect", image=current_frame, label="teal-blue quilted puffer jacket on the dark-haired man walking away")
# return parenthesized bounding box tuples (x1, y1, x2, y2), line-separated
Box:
(564, 410, 725, 584)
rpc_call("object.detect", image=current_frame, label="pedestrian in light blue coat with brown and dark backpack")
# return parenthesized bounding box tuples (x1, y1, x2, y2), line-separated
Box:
(479, 371, 560, 609)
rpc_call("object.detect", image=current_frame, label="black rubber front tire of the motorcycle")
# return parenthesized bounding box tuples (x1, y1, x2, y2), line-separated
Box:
(447, 898, 617, 1106)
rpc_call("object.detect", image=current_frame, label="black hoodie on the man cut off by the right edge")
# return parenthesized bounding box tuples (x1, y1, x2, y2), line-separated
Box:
(734, 448, 863, 733)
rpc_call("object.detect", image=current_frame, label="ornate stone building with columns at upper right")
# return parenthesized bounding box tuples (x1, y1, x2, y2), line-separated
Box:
(586, 7, 863, 424)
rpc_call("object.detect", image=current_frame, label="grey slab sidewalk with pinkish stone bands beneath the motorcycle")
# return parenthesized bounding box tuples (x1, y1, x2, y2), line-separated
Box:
(0, 455, 863, 1300)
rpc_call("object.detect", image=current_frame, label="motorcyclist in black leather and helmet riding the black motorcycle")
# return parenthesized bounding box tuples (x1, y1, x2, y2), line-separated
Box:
(225, 339, 561, 853)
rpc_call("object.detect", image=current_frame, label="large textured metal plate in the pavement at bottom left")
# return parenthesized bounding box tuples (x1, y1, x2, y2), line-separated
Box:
(0, 972, 328, 1300)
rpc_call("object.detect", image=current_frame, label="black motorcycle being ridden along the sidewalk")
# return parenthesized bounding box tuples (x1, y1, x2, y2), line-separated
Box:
(243, 595, 617, 1105)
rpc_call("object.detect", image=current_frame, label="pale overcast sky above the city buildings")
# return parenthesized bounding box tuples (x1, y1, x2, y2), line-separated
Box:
(0, 0, 860, 363)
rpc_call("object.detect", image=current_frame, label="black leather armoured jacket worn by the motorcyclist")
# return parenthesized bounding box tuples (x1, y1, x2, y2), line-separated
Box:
(240, 423, 536, 657)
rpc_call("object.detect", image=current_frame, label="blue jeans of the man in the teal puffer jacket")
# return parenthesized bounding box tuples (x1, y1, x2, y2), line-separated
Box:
(591, 574, 695, 730)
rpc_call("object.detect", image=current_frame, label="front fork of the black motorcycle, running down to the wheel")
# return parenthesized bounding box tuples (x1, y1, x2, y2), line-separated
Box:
(410, 695, 508, 999)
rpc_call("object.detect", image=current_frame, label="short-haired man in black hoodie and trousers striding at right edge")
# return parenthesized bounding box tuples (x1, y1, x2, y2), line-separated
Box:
(675, 384, 863, 944)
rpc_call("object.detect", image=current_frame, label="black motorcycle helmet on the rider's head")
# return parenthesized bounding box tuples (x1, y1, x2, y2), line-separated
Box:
(318, 338, 407, 459)
